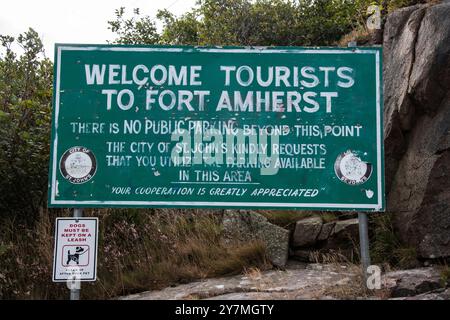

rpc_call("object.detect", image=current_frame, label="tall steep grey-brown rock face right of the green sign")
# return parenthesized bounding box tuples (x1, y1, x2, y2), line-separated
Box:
(383, 3, 450, 258)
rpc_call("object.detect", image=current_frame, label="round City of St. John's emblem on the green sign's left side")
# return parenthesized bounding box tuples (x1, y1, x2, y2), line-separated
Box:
(59, 147, 97, 184)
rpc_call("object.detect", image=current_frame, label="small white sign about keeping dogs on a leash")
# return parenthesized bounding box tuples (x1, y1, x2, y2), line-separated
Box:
(53, 218, 98, 282)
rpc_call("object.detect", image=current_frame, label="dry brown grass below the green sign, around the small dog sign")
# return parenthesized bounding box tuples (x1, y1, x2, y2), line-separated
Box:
(0, 209, 269, 299)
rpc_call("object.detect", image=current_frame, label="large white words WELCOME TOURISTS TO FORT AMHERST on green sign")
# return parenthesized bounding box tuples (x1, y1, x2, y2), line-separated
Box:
(88, 64, 355, 113)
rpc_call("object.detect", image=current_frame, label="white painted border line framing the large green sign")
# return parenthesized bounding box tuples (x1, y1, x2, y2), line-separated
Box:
(48, 43, 385, 211)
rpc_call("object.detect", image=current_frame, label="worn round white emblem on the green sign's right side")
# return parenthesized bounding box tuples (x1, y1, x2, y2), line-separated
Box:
(334, 150, 372, 185)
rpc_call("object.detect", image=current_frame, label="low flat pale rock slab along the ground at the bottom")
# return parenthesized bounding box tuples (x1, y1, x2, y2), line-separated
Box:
(119, 261, 450, 300)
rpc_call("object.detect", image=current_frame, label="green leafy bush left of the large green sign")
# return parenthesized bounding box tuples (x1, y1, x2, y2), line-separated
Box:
(0, 29, 53, 225)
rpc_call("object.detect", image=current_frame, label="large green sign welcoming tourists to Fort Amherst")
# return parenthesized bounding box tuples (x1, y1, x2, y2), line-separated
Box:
(49, 44, 385, 211)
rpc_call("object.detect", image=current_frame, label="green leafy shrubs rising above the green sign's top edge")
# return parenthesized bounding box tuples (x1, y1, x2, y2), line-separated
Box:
(109, 0, 368, 46)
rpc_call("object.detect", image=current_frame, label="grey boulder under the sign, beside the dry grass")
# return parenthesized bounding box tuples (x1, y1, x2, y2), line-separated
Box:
(222, 210, 289, 267)
